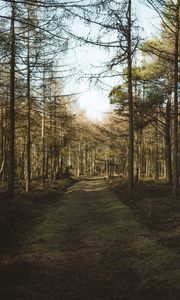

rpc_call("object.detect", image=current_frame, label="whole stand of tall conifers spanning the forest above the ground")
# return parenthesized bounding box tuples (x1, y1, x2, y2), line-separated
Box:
(0, 0, 180, 197)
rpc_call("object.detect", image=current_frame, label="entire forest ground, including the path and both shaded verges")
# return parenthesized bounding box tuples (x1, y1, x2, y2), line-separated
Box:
(0, 177, 180, 300)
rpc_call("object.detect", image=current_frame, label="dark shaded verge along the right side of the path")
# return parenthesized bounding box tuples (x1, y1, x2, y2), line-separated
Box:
(111, 178, 180, 253)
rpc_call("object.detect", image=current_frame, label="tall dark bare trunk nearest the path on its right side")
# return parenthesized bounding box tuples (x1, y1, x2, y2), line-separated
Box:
(128, 0, 134, 196)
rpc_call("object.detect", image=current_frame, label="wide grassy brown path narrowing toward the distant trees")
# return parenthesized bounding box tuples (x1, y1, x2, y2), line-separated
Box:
(0, 178, 180, 300)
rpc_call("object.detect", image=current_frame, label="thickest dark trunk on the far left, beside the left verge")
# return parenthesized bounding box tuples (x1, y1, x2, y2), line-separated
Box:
(8, 1, 15, 197)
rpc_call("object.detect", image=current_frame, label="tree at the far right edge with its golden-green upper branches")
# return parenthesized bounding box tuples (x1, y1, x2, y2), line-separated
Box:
(145, 0, 180, 197)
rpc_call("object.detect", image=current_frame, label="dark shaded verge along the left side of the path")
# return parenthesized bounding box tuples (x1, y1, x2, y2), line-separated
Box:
(0, 179, 74, 255)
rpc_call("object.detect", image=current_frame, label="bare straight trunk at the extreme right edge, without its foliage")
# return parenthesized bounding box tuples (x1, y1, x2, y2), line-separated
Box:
(173, 0, 180, 197)
